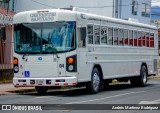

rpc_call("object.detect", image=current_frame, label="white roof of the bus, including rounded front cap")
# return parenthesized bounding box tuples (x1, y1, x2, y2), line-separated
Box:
(13, 9, 157, 29)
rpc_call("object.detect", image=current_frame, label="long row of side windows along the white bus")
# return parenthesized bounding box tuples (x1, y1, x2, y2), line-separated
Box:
(87, 24, 154, 47)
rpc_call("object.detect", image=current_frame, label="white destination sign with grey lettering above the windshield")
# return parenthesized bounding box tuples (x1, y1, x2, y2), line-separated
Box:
(30, 13, 56, 22)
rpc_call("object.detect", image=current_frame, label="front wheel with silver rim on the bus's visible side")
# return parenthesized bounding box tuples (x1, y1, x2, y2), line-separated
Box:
(86, 68, 101, 94)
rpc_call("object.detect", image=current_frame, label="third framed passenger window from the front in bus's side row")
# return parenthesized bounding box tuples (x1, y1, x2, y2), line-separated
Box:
(101, 26, 107, 44)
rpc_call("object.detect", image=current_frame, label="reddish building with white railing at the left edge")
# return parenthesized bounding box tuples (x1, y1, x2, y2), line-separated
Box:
(0, 0, 15, 70)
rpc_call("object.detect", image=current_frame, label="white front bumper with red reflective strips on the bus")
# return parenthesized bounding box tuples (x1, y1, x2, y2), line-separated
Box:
(13, 77, 77, 87)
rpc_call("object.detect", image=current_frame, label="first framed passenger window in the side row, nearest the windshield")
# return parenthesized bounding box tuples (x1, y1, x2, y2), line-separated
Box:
(87, 25, 93, 44)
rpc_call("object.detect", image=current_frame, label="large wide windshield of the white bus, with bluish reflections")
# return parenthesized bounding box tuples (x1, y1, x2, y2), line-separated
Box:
(14, 22, 76, 54)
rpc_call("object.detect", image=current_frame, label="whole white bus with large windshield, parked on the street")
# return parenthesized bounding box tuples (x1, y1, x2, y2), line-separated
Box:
(13, 9, 158, 94)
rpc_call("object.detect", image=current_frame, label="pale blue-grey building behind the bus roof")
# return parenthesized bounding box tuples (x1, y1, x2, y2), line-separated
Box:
(15, 0, 151, 24)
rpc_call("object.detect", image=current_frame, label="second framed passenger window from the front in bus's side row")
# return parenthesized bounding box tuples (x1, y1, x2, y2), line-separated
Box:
(94, 25, 100, 44)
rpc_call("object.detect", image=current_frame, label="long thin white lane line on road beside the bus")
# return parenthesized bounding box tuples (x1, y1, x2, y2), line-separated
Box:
(66, 91, 146, 104)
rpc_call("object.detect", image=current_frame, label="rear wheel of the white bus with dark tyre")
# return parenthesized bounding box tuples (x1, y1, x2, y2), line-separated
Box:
(130, 65, 148, 87)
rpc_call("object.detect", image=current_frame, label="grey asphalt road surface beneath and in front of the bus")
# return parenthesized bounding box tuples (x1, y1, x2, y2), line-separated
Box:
(0, 80, 160, 113)
